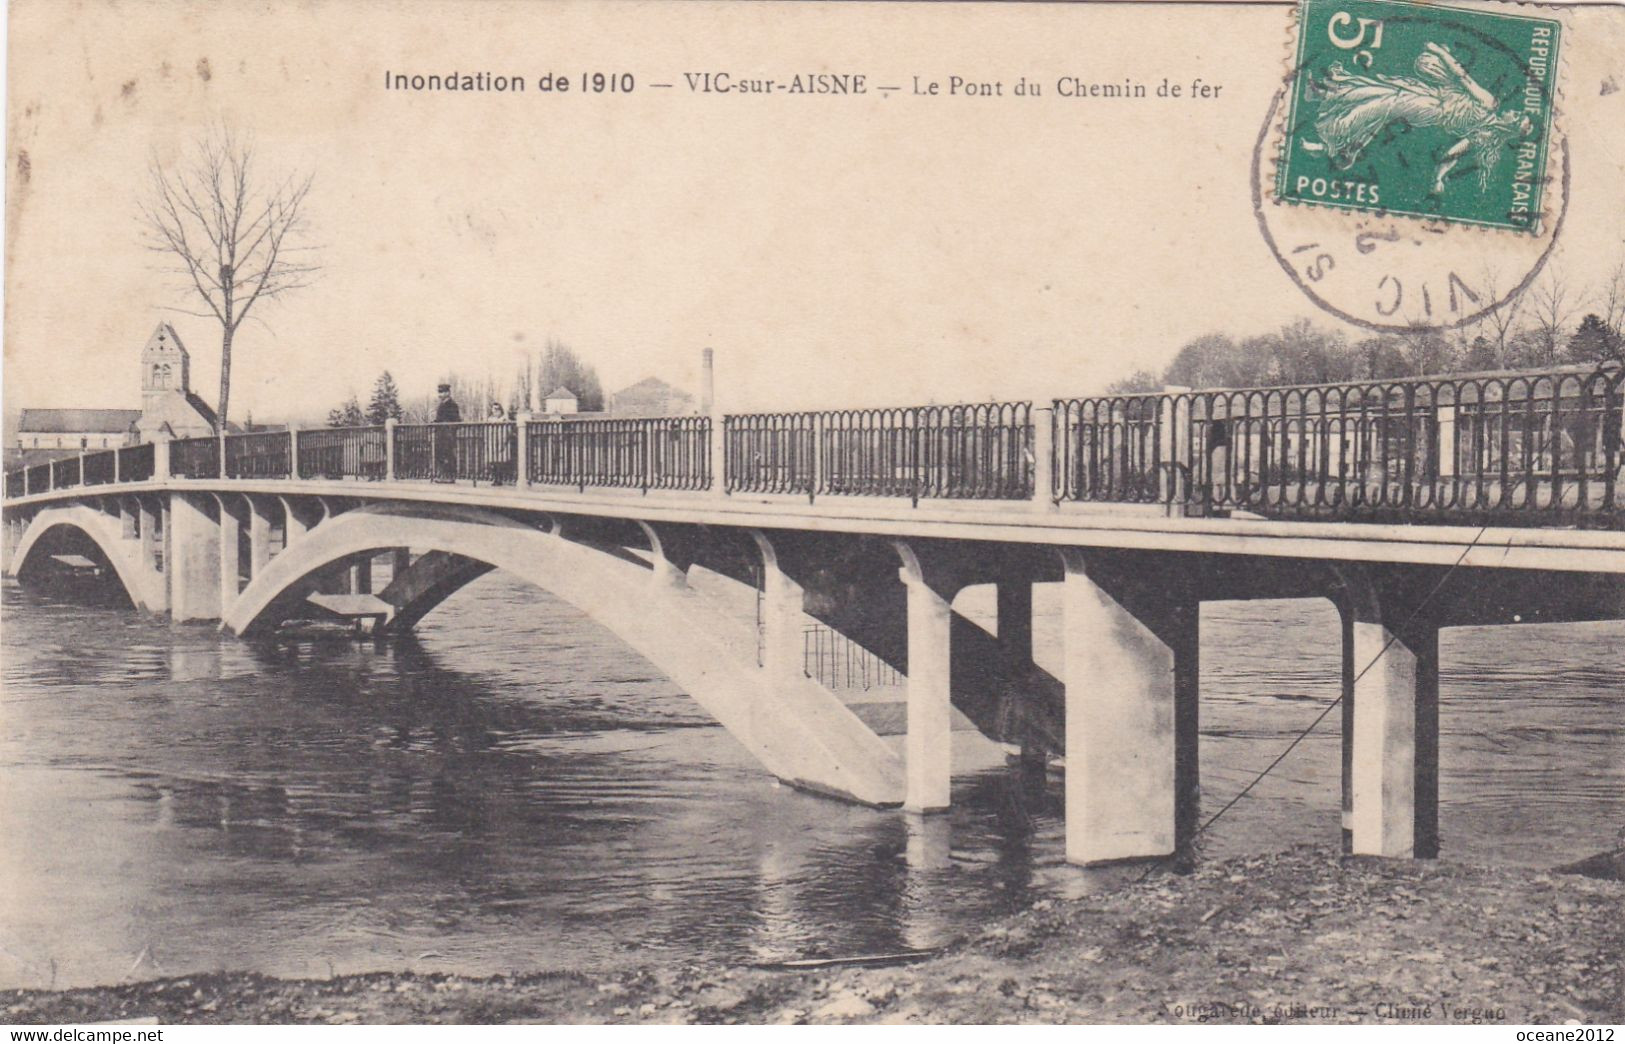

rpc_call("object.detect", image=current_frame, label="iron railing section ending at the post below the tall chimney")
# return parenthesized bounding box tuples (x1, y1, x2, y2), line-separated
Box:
(525, 416, 712, 491)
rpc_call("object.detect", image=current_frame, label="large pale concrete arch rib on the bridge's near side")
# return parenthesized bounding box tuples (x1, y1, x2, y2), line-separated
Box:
(221, 502, 902, 805)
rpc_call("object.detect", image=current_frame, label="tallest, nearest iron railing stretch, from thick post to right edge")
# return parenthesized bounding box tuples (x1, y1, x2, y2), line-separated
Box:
(1051, 368, 1622, 525)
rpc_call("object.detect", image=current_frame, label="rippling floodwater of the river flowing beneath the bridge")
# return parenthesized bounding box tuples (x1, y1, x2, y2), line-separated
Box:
(0, 574, 1625, 987)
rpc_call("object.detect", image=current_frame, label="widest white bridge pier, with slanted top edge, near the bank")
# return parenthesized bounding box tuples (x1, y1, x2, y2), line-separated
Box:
(1063, 550, 1199, 865)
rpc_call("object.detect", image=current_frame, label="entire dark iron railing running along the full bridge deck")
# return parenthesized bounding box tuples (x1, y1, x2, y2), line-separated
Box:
(5, 364, 1625, 529)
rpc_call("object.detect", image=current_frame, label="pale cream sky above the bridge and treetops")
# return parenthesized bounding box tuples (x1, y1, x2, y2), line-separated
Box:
(3, 0, 1625, 420)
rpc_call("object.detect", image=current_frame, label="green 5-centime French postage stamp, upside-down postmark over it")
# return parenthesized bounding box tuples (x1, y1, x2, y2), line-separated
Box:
(1276, 0, 1560, 231)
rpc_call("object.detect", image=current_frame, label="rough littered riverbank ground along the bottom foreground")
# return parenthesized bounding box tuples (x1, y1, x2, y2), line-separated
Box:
(0, 847, 1625, 1023)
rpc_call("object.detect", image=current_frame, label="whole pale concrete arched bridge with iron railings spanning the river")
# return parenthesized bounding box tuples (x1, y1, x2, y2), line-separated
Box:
(3, 368, 1625, 863)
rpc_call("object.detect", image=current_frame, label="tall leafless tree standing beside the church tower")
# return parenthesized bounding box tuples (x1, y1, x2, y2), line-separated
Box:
(140, 128, 319, 431)
